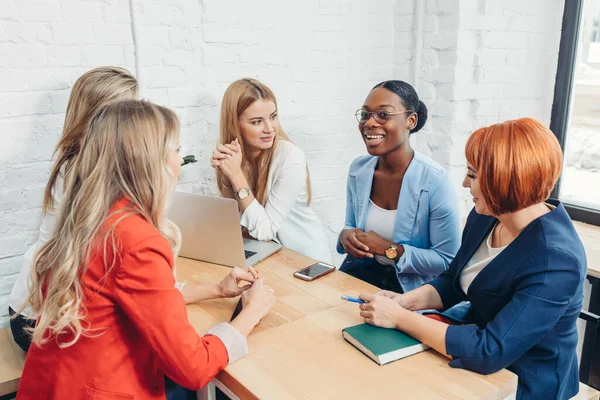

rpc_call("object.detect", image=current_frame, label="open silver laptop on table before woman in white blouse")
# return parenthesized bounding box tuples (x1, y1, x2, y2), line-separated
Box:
(167, 192, 282, 267)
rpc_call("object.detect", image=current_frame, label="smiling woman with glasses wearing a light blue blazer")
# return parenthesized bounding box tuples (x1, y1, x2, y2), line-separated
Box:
(337, 81, 460, 293)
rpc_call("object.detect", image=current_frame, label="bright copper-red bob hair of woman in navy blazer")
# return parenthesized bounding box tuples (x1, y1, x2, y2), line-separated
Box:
(465, 118, 563, 215)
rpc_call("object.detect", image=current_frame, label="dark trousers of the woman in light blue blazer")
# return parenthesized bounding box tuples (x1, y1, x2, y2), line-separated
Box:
(340, 256, 404, 293)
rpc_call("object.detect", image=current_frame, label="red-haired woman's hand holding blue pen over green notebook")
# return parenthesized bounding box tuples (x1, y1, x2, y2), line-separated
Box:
(358, 293, 410, 329)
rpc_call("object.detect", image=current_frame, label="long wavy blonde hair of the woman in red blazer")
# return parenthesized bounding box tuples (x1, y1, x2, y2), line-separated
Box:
(27, 100, 181, 347)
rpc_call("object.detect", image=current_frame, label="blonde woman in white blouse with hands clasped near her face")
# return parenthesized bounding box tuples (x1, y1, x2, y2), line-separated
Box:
(211, 79, 331, 262)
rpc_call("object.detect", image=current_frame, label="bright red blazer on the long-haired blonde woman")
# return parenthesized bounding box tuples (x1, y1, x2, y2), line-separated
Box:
(17, 200, 229, 400)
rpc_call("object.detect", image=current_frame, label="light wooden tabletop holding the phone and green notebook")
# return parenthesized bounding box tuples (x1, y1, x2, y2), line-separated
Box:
(177, 249, 517, 400)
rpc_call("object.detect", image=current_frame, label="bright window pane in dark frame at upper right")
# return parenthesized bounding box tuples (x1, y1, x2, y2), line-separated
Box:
(560, 0, 600, 209)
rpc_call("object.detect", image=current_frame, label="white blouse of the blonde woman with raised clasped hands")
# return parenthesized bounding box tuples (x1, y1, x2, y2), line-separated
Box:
(240, 140, 331, 263)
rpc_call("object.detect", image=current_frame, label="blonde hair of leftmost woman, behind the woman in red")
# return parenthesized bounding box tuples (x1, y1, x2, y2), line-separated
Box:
(42, 67, 138, 214)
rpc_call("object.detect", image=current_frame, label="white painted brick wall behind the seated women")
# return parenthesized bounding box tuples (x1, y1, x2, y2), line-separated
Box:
(0, 0, 564, 319)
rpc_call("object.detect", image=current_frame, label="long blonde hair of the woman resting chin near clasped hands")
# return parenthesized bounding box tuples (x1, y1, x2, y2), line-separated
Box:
(217, 78, 311, 206)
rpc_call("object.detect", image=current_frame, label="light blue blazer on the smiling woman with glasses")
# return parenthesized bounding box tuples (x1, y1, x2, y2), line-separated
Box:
(337, 152, 461, 292)
